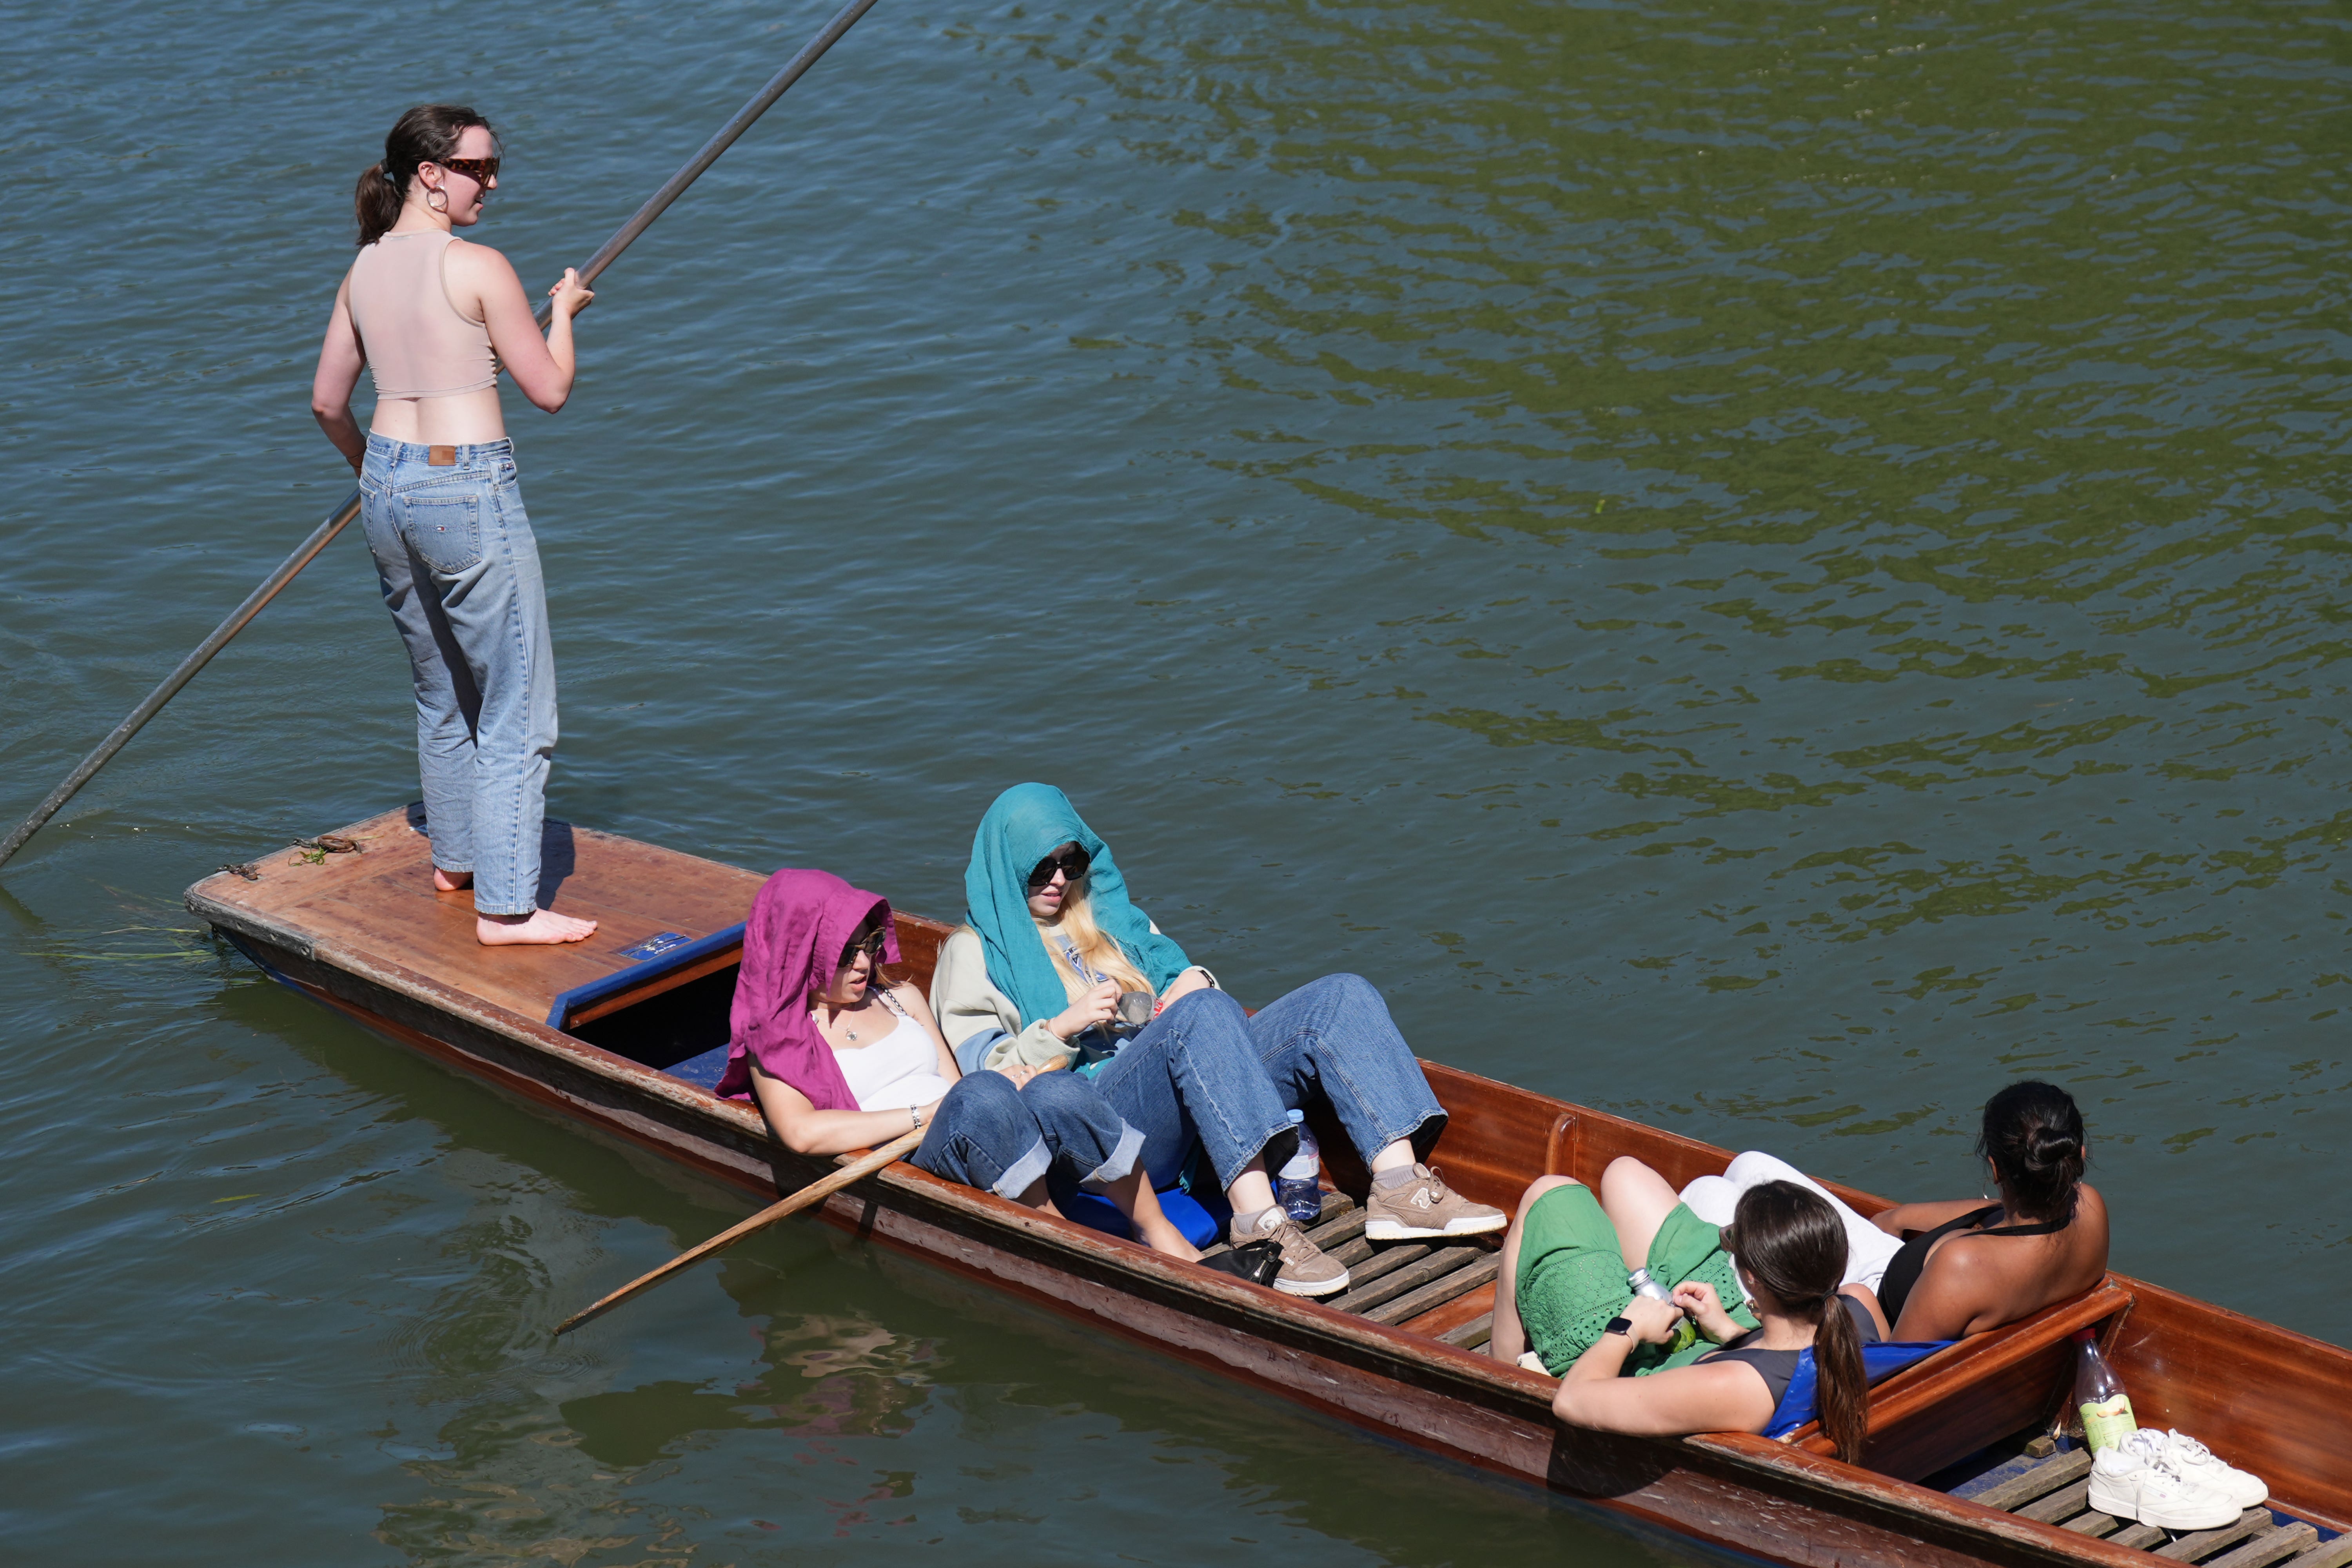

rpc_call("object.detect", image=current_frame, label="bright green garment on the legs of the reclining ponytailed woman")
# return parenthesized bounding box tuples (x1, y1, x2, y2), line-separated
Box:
(1517, 1185, 1757, 1377)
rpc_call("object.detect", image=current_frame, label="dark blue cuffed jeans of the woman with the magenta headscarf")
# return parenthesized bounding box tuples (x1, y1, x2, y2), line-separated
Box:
(915, 1072, 1143, 1199)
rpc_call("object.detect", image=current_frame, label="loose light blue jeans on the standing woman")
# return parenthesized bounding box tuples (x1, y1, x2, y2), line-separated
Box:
(360, 435, 555, 915)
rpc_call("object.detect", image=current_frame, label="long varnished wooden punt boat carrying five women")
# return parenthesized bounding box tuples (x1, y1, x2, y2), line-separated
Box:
(188, 809, 2352, 1568)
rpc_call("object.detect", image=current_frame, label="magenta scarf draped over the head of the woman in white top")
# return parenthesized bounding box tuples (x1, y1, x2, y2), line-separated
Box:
(717, 867, 898, 1110)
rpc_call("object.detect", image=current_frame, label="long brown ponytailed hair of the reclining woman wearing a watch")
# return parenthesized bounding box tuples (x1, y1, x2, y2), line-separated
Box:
(1724, 1182, 1870, 1465)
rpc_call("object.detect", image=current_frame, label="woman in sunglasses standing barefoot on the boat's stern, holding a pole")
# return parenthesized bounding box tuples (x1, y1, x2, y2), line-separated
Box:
(310, 103, 595, 945)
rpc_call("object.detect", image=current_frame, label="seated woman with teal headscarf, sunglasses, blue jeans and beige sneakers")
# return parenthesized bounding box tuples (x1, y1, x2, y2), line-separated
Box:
(931, 783, 1510, 1295)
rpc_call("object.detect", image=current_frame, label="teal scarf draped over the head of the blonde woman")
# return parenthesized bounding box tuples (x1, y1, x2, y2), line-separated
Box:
(964, 785, 1192, 1027)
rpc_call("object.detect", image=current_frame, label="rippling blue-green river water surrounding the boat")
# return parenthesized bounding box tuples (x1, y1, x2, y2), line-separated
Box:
(0, 0, 2352, 1568)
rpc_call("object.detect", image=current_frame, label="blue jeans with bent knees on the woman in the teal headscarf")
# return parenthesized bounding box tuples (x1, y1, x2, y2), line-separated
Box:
(1094, 976, 1446, 1187)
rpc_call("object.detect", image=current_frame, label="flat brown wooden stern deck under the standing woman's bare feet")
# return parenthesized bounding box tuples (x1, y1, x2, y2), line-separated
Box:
(202, 806, 762, 1023)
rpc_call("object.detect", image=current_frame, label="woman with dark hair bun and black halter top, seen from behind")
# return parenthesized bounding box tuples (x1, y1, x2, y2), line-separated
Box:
(1872, 1079, 2107, 1340)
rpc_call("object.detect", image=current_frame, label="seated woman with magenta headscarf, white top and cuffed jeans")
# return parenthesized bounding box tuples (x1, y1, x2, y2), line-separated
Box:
(717, 870, 1200, 1260)
